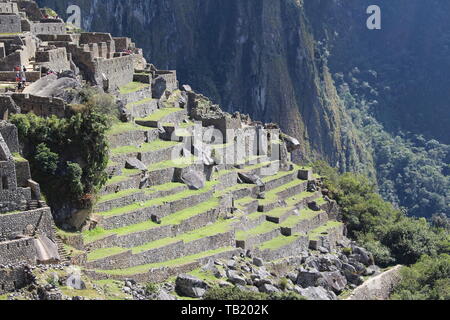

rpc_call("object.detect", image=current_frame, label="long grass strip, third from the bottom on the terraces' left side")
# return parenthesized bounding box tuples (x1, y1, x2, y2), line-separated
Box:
(83, 198, 219, 243)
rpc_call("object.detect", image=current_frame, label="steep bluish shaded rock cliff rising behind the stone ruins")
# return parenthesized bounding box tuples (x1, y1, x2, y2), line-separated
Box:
(40, 0, 370, 174)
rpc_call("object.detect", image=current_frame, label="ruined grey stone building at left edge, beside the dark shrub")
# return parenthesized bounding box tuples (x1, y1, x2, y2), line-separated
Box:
(0, 121, 59, 274)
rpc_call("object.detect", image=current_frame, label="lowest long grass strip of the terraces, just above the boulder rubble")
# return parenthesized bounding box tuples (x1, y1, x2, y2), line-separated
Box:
(95, 247, 235, 276)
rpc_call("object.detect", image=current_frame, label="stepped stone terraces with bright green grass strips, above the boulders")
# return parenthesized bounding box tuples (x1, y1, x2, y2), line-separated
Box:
(63, 82, 340, 281)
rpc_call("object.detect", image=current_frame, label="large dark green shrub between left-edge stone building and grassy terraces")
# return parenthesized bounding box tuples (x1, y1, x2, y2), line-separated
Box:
(11, 95, 111, 209)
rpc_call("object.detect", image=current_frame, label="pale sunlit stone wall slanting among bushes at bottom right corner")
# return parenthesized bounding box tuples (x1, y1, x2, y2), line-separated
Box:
(347, 265, 403, 300)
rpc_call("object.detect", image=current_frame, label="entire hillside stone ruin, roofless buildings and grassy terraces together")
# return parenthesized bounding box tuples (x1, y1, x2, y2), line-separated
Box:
(0, 1, 350, 293)
